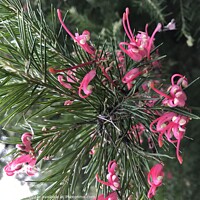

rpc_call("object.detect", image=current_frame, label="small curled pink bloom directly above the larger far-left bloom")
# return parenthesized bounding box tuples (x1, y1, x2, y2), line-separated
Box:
(16, 132, 33, 152)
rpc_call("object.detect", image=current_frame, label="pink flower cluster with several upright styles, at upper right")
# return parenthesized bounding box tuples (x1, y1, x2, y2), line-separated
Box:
(119, 8, 162, 62)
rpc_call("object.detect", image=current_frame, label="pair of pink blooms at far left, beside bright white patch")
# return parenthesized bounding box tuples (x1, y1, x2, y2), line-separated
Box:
(4, 133, 37, 176)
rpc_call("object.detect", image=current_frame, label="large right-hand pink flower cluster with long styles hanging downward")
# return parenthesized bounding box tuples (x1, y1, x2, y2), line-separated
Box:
(150, 112, 189, 164)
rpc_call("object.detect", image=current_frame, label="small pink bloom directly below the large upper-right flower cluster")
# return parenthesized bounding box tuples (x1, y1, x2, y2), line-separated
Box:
(122, 68, 144, 90)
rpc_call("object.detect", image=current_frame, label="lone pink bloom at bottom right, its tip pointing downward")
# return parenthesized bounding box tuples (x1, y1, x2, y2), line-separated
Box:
(147, 163, 164, 198)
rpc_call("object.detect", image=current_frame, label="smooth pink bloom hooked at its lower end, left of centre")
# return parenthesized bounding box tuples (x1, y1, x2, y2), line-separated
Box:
(78, 69, 96, 98)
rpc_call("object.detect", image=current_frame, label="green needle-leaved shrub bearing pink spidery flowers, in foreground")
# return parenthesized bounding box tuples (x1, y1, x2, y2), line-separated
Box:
(0, 2, 199, 200)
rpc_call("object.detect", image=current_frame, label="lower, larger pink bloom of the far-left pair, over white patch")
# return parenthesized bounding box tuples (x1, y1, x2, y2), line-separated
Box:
(4, 154, 37, 176)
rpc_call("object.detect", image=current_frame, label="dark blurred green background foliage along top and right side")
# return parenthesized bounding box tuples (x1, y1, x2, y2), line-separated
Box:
(0, 0, 200, 200)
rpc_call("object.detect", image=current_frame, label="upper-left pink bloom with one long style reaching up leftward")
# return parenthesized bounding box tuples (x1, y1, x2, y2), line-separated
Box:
(57, 9, 95, 55)
